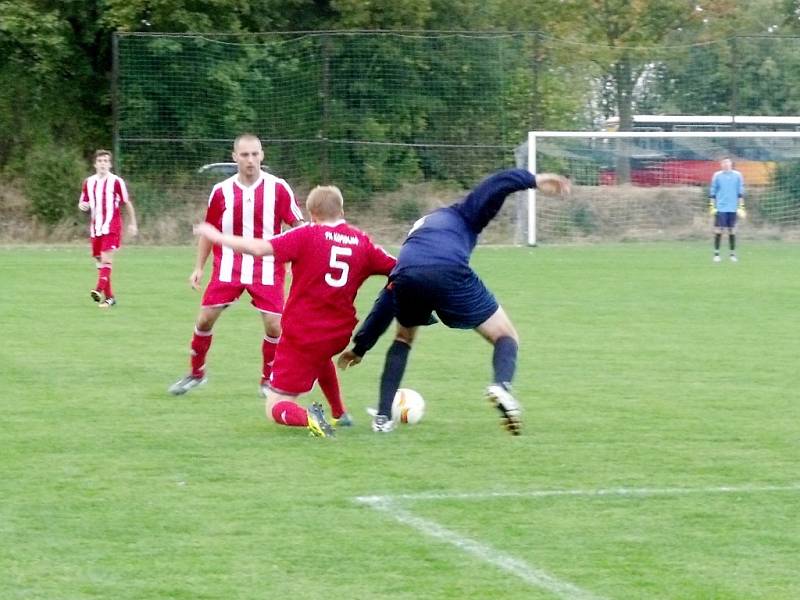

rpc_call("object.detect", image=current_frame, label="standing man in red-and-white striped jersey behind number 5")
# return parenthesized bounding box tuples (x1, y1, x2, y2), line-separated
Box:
(169, 134, 312, 395)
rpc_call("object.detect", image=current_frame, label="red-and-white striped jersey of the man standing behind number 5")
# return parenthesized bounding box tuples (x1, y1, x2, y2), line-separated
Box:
(206, 171, 303, 289)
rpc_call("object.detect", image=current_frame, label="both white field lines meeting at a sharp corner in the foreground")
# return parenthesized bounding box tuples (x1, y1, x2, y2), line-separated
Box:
(355, 483, 800, 600)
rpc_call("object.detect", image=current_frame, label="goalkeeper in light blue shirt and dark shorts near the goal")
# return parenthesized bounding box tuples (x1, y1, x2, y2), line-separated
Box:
(708, 157, 747, 262)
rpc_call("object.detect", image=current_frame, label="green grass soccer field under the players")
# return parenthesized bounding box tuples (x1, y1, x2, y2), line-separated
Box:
(0, 242, 800, 600)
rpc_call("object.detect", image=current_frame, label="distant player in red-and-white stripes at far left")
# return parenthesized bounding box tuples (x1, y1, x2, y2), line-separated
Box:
(78, 150, 139, 308)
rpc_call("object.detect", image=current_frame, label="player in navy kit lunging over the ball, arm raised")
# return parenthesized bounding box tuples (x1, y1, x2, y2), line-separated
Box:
(338, 169, 570, 435)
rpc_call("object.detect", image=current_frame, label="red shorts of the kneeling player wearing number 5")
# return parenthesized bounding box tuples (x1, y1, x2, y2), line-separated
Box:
(269, 332, 350, 396)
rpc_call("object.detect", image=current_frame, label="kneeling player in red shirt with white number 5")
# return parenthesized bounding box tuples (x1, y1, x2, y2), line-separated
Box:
(194, 186, 396, 437)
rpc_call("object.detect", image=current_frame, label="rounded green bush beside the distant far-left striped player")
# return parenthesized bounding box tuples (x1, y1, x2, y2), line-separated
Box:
(23, 144, 87, 225)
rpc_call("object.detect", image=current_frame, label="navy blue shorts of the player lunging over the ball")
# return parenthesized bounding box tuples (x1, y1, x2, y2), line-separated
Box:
(391, 266, 499, 329)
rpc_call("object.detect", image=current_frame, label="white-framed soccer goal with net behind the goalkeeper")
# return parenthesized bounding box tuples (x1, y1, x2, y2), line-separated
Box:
(517, 131, 800, 245)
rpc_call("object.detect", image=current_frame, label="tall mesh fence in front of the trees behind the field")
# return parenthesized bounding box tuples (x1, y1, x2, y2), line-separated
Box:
(114, 32, 800, 242)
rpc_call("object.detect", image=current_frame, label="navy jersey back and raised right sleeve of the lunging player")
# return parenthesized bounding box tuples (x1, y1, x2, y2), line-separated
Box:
(392, 169, 536, 273)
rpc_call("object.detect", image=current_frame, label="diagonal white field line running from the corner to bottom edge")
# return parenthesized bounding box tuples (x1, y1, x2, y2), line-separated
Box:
(356, 496, 602, 600)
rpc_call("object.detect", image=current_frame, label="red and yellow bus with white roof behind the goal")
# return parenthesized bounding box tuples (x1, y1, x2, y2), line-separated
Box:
(599, 115, 800, 186)
